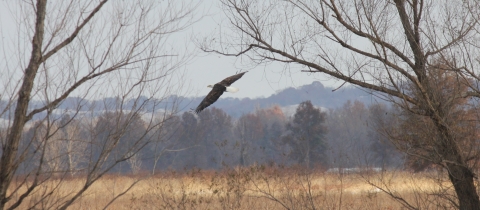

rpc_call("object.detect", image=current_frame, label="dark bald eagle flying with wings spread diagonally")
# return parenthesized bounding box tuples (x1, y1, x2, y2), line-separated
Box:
(195, 72, 247, 114)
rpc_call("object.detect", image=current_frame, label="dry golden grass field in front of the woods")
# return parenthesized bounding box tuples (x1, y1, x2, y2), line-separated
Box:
(7, 167, 464, 210)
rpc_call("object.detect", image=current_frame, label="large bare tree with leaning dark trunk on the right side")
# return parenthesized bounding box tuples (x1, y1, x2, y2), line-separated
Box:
(201, 0, 480, 209)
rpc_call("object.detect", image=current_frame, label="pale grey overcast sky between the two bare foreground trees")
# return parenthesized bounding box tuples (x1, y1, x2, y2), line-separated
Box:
(0, 0, 335, 98)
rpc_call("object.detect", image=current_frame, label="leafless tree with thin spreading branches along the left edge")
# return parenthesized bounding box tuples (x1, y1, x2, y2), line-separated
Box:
(0, 0, 196, 209)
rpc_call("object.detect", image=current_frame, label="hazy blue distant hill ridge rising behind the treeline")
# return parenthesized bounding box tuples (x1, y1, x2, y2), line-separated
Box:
(0, 81, 373, 119)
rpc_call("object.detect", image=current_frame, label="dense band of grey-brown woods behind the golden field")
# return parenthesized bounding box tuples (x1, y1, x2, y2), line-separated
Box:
(12, 101, 404, 176)
